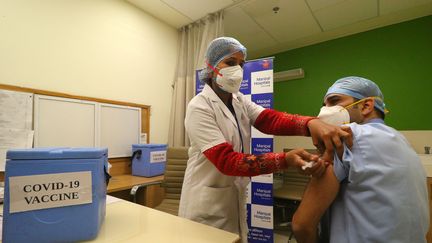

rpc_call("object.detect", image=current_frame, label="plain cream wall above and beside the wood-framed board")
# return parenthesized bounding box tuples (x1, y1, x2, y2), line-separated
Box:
(0, 0, 178, 143)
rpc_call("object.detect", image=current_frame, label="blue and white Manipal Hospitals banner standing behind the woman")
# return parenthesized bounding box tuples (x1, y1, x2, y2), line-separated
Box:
(195, 58, 273, 243)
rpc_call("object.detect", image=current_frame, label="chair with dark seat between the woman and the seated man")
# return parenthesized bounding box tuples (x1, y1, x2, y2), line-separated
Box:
(273, 161, 310, 242)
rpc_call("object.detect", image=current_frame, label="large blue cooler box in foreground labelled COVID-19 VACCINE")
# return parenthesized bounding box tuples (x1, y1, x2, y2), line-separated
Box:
(3, 148, 108, 243)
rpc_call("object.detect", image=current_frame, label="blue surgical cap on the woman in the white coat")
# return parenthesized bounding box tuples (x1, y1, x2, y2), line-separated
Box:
(199, 37, 246, 82)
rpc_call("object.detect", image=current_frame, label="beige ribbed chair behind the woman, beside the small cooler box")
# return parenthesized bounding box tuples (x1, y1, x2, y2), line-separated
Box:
(155, 147, 188, 216)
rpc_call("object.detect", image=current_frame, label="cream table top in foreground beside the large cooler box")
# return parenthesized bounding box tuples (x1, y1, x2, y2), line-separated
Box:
(88, 200, 240, 243)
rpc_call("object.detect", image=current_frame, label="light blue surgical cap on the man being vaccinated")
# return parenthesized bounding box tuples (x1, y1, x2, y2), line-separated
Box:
(324, 76, 386, 113)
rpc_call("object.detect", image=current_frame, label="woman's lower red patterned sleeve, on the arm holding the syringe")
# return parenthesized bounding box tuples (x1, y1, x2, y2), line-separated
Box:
(204, 143, 288, 176)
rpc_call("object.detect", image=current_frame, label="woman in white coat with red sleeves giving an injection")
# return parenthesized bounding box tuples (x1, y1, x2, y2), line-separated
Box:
(179, 37, 351, 242)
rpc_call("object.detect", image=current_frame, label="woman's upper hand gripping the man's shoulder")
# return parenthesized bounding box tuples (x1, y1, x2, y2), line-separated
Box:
(307, 119, 352, 162)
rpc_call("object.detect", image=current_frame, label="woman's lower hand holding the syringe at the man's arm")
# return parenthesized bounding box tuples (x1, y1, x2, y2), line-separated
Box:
(285, 149, 328, 177)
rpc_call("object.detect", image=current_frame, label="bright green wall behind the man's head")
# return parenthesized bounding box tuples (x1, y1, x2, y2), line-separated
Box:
(274, 16, 432, 130)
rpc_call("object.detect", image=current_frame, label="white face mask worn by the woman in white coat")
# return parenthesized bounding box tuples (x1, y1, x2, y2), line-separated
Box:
(216, 65, 243, 93)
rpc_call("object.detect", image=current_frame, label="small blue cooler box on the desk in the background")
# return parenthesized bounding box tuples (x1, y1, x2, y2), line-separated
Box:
(132, 144, 167, 177)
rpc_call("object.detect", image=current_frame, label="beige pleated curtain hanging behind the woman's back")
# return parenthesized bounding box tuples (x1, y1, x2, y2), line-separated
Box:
(168, 11, 223, 147)
